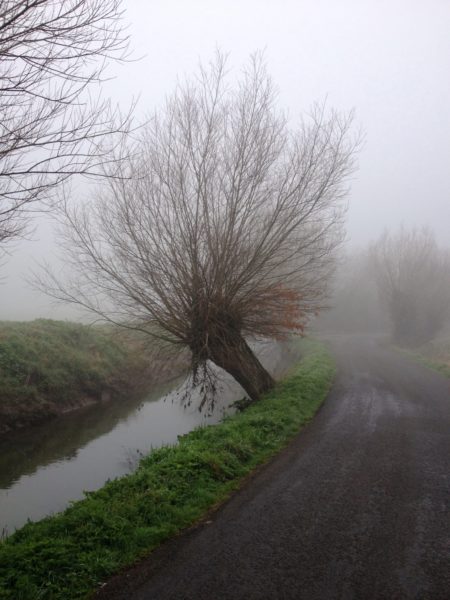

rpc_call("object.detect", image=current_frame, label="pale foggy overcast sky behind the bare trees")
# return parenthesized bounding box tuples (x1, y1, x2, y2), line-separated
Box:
(0, 0, 450, 319)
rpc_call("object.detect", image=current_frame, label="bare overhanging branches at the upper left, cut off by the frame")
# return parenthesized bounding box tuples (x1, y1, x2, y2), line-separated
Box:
(0, 0, 132, 248)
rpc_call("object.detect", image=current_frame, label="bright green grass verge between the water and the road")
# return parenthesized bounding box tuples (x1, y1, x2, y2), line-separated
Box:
(0, 341, 334, 600)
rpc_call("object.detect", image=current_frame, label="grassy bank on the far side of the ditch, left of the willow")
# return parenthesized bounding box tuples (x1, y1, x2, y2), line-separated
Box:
(0, 319, 185, 433)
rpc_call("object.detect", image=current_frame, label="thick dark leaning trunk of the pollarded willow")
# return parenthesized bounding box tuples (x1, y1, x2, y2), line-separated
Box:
(209, 335, 275, 401)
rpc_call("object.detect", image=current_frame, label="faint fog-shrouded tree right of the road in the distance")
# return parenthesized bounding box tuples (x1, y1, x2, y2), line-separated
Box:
(371, 229, 450, 346)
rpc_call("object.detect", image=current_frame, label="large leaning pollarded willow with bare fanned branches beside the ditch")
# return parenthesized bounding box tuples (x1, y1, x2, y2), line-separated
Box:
(45, 55, 357, 400)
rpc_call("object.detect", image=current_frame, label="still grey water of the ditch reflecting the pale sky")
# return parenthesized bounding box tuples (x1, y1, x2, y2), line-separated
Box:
(0, 346, 294, 535)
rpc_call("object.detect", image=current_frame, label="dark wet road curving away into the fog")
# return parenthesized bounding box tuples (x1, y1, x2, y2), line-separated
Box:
(98, 337, 450, 600)
